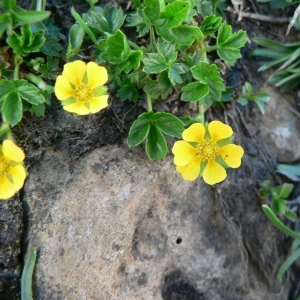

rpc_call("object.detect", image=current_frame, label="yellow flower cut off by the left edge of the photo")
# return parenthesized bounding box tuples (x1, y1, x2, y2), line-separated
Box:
(0, 140, 27, 200)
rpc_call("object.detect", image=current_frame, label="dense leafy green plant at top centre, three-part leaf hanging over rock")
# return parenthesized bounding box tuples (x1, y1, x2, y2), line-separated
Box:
(69, 0, 247, 166)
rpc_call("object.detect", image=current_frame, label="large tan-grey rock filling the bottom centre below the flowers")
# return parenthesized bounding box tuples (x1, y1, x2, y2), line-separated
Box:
(24, 144, 289, 300)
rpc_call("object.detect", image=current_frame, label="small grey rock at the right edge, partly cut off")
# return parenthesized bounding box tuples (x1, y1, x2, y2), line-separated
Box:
(259, 86, 300, 163)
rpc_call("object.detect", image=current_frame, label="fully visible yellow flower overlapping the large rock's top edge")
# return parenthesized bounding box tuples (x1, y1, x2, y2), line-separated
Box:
(172, 121, 244, 184)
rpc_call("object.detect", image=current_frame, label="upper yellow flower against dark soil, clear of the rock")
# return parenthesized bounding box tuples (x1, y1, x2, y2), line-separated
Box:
(54, 60, 108, 115)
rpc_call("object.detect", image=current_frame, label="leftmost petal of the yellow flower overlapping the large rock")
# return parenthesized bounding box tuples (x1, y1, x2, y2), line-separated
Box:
(172, 141, 198, 166)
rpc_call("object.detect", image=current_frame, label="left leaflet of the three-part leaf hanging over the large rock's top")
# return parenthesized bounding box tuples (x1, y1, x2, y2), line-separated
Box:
(127, 112, 154, 147)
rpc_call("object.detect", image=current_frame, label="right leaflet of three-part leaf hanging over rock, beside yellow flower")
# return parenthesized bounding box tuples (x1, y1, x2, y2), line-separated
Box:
(151, 112, 184, 138)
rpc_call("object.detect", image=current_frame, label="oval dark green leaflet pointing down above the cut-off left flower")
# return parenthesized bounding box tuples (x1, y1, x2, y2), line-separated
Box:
(2, 91, 23, 126)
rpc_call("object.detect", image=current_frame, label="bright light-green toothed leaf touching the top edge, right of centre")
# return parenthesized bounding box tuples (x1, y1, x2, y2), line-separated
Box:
(159, 0, 191, 29)
